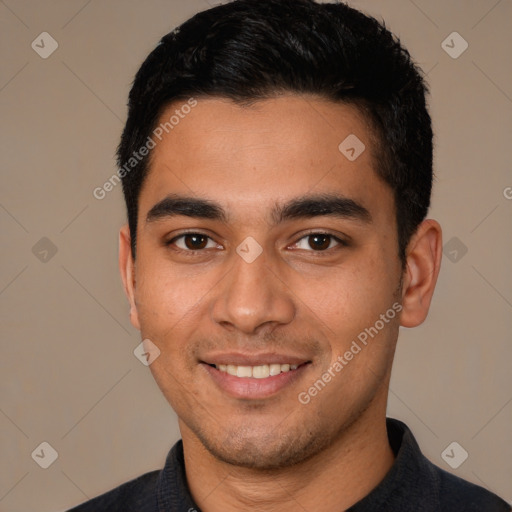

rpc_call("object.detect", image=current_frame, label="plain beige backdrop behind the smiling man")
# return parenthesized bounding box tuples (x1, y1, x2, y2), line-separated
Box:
(0, 0, 512, 512)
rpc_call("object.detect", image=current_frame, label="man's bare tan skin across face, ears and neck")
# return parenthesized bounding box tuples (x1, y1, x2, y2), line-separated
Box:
(119, 94, 442, 512)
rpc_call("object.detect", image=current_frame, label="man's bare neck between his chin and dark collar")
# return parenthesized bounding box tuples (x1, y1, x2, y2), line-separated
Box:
(180, 404, 394, 512)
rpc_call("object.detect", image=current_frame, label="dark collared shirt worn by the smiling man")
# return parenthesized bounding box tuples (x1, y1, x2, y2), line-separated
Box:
(68, 418, 512, 512)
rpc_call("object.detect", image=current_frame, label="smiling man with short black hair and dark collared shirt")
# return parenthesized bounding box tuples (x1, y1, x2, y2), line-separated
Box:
(69, 0, 510, 512)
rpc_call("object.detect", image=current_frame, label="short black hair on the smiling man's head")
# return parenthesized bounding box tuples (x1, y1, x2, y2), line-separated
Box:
(117, 0, 433, 265)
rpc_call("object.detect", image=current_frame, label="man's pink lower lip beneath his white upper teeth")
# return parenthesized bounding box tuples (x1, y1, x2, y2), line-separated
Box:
(201, 363, 310, 400)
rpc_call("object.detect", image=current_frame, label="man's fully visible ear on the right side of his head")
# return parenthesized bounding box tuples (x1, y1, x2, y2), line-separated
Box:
(400, 219, 443, 327)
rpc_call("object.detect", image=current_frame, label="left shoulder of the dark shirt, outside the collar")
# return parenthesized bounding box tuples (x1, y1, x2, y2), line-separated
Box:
(68, 470, 160, 512)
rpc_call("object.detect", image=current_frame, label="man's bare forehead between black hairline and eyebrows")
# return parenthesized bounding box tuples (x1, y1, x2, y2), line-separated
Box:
(136, 95, 392, 224)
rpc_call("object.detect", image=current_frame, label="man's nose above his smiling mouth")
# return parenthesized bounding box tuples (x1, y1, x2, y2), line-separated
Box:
(212, 244, 295, 335)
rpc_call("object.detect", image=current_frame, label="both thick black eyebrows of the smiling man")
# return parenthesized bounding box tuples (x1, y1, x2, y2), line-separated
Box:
(146, 194, 372, 224)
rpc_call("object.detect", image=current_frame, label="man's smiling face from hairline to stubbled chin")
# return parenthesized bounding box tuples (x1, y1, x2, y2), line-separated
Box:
(122, 95, 402, 468)
